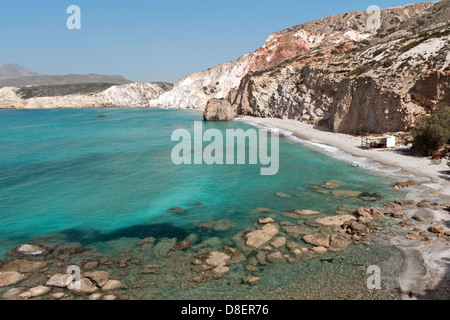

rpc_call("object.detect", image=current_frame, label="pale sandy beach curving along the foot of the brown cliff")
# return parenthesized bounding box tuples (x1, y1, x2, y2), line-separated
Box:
(239, 116, 450, 299)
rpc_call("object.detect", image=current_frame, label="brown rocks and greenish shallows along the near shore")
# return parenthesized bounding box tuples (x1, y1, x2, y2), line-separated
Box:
(0, 181, 450, 300)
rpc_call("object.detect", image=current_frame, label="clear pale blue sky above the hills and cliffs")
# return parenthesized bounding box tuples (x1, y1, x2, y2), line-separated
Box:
(0, 0, 417, 82)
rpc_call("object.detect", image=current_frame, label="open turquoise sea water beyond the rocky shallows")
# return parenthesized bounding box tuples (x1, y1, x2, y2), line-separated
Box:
(0, 108, 401, 297)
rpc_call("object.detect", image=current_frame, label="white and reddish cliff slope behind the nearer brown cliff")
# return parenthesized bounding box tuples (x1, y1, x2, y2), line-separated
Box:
(150, 2, 440, 109)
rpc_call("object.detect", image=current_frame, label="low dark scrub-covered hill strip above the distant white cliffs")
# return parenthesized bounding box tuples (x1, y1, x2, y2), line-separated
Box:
(0, 69, 132, 88)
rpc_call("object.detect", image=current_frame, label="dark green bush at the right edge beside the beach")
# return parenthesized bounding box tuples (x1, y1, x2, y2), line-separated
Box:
(413, 106, 450, 155)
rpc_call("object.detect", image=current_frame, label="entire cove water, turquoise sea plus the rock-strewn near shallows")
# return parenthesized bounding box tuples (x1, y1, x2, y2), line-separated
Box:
(0, 108, 448, 299)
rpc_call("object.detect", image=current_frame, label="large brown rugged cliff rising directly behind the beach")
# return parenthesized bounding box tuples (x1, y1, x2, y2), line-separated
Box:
(221, 1, 450, 134)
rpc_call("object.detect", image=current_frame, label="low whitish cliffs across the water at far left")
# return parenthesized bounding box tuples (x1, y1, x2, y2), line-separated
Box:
(0, 83, 171, 109)
